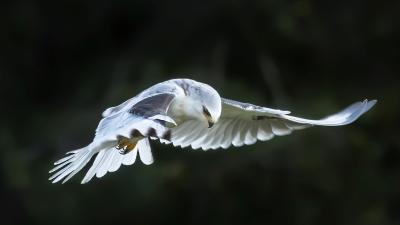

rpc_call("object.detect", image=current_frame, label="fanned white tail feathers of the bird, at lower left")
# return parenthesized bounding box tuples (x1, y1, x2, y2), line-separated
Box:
(49, 138, 153, 183)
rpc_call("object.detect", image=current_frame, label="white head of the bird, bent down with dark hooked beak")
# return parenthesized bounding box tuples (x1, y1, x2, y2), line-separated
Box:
(180, 80, 222, 128)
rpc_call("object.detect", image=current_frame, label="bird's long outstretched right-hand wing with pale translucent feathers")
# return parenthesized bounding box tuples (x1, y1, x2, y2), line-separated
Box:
(164, 99, 376, 150)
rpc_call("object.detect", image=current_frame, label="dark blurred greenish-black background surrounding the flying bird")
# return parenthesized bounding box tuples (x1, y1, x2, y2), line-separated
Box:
(0, 0, 400, 225)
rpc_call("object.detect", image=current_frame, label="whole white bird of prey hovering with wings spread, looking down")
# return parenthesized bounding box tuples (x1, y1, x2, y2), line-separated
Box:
(49, 78, 377, 184)
